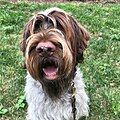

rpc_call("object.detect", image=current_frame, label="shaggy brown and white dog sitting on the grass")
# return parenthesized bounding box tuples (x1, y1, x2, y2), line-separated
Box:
(20, 8, 90, 120)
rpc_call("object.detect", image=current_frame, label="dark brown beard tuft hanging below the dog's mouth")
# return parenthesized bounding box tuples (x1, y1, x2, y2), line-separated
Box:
(42, 76, 71, 100)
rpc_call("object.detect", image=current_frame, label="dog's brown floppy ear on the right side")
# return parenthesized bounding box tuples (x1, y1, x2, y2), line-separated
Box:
(69, 16, 90, 63)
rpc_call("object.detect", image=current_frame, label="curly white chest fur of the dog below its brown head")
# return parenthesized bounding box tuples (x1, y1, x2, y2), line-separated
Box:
(25, 69, 89, 120)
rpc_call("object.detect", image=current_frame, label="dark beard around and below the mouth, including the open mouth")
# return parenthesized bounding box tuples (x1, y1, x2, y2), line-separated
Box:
(29, 57, 72, 100)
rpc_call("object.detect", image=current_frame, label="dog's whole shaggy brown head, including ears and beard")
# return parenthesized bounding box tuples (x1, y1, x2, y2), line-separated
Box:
(21, 8, 90, 97)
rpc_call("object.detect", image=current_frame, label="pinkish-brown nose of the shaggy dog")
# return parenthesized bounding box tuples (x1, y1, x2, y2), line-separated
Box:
(36, 41, 56, 54)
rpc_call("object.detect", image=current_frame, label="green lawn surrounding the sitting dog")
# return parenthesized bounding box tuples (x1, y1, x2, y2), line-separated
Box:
(0, 0, 120, 120)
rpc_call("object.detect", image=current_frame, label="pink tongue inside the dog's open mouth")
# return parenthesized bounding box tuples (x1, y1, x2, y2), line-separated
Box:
(43, 66, 58, 80)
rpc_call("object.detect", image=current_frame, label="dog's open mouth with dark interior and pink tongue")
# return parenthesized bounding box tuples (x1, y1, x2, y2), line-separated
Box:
(42, 60, 58, 80)
